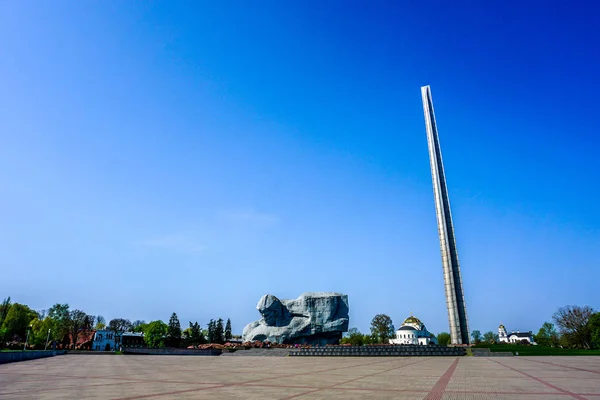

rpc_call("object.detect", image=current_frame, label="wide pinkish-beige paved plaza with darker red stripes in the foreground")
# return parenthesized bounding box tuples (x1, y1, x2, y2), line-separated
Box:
(0, 355, 600, 400)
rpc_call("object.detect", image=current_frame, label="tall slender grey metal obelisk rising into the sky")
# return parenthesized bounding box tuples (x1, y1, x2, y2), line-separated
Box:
(421, 86, 469, 344)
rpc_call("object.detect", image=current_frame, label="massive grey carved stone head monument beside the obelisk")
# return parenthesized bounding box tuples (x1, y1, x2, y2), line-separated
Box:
(242, 292, 348, 345)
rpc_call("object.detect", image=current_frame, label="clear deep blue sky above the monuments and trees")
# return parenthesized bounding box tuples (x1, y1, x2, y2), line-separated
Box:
(0, 1, 600, 333)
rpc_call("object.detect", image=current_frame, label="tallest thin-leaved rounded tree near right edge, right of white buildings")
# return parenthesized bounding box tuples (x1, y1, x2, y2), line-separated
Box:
(552, 306, 594, 349)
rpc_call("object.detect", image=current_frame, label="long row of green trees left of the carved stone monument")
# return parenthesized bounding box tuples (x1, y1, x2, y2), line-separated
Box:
(0, 297, 233, 349)
